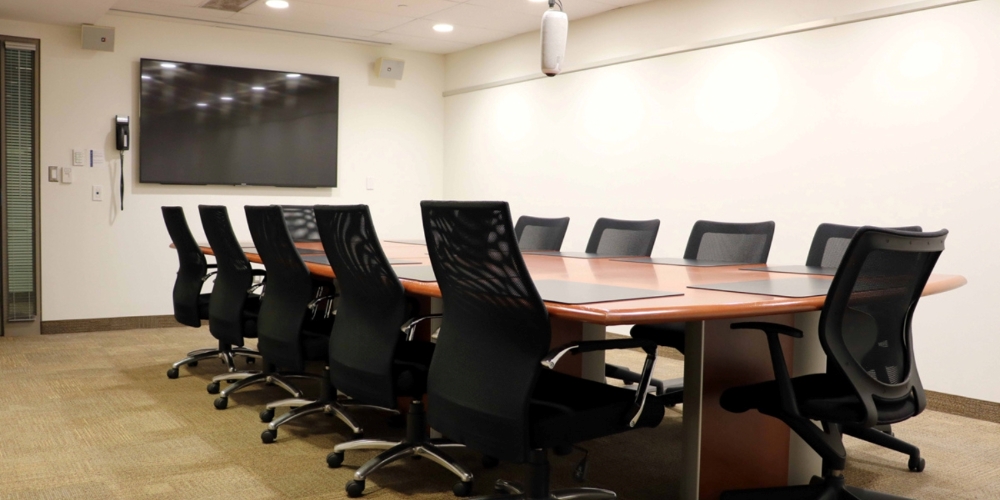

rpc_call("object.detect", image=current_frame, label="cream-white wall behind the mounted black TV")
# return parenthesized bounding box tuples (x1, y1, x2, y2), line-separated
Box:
(0, 15, 444, 321)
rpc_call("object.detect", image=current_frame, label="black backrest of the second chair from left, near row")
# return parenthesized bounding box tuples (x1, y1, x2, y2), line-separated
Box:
(198, 205, 253, 346)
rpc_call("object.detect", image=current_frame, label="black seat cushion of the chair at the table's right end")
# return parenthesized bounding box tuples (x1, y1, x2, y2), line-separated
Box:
(719, 373, 917, 424)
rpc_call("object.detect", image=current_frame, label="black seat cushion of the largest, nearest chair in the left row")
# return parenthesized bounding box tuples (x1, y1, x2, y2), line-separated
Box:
(530, 370, 664, 448)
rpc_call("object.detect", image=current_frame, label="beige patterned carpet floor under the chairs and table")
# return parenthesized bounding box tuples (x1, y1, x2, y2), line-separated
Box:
(0, 328, 1000, 500)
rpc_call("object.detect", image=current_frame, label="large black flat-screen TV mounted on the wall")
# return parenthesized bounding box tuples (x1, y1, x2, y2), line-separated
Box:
(138, 59, 340, 187)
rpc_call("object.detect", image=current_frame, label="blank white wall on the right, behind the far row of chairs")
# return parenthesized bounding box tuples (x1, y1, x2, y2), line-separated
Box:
(444, 0, 1000, 401)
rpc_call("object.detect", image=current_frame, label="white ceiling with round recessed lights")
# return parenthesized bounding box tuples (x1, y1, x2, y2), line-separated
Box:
(0, 0, 647, 54)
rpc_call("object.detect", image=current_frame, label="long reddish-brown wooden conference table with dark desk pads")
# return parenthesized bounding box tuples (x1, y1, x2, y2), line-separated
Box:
(202, 241, 966, 499)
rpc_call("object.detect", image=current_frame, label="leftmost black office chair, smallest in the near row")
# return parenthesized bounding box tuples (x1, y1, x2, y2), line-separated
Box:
(161, 207, 259, 378)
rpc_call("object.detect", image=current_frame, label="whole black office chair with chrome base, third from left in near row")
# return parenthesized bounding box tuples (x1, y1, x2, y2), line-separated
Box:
(234, 206, 361, 444)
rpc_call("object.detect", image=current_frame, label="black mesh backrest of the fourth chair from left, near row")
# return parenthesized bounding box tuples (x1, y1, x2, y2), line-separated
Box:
(316, 205, 407, 408)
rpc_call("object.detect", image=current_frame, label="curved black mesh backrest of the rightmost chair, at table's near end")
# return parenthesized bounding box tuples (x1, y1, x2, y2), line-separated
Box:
(819, 227, 948, 426)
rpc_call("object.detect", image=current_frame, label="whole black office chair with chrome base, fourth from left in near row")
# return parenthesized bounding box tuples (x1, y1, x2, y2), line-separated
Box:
(316, 205, 472, 497)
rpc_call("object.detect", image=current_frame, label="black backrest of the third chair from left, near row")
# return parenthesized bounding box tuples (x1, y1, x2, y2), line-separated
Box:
(245, 205, 312, 371)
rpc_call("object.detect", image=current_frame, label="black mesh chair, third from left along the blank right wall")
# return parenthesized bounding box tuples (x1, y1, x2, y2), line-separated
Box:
(604, 220, 774, 400)
